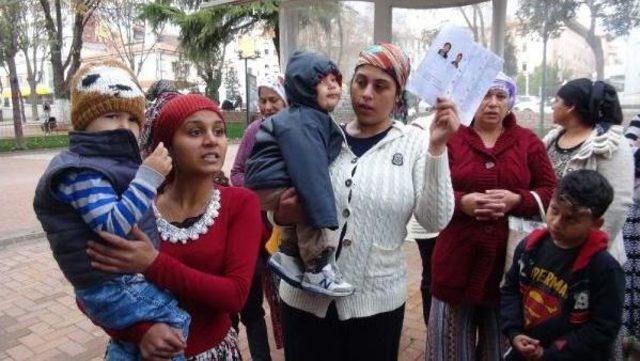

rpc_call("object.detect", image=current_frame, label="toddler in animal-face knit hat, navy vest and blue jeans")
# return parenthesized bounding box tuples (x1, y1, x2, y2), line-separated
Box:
(34, 61, 190, 360)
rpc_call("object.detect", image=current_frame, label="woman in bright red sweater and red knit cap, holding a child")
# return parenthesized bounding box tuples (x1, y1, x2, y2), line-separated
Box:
(89, 94, 263, 361)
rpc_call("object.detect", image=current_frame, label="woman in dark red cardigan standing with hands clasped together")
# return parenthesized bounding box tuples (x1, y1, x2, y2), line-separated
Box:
(427, 73, 556, 361)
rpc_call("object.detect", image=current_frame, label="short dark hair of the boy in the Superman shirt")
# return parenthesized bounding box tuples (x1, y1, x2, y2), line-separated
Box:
(553, 169, 613, 218)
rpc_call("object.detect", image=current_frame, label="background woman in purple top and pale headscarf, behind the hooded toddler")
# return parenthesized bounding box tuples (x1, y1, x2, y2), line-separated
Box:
(230, 76, 287, 361)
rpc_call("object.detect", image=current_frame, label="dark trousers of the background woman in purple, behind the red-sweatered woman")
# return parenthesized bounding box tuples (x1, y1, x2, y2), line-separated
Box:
(231, 255, 273, 361)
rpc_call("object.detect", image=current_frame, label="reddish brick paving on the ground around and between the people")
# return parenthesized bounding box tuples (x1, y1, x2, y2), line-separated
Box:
(0, 238, 426, 361)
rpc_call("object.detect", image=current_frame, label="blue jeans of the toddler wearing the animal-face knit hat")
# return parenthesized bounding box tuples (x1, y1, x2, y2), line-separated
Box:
(75, 274, 191, 361)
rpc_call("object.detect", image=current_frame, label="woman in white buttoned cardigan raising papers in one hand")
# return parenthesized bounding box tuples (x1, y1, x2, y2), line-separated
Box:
(275, 44, 459, 361)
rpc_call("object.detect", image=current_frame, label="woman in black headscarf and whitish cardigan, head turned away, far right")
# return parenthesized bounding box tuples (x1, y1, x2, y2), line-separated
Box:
(543, 78, 634, 264)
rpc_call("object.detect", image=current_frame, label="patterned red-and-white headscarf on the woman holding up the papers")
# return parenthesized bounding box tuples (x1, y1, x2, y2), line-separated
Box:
(356, 43, 411, 120)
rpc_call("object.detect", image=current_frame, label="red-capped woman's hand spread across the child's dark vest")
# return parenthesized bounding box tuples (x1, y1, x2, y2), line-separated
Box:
(87, 226, 158, 273)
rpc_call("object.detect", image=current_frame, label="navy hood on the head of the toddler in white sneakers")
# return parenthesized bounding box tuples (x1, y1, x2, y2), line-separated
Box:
(284, 51, 340, 112)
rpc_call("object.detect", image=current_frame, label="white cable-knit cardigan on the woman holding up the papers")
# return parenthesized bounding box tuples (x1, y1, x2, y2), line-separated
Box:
(280, 122, 454, 320)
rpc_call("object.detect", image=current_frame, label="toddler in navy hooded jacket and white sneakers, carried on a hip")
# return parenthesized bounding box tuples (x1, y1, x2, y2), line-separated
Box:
(244, 51, 354, 297)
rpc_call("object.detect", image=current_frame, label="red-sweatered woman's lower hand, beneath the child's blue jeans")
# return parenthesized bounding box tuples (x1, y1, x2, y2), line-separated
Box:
(139, 323, 187, 361)
